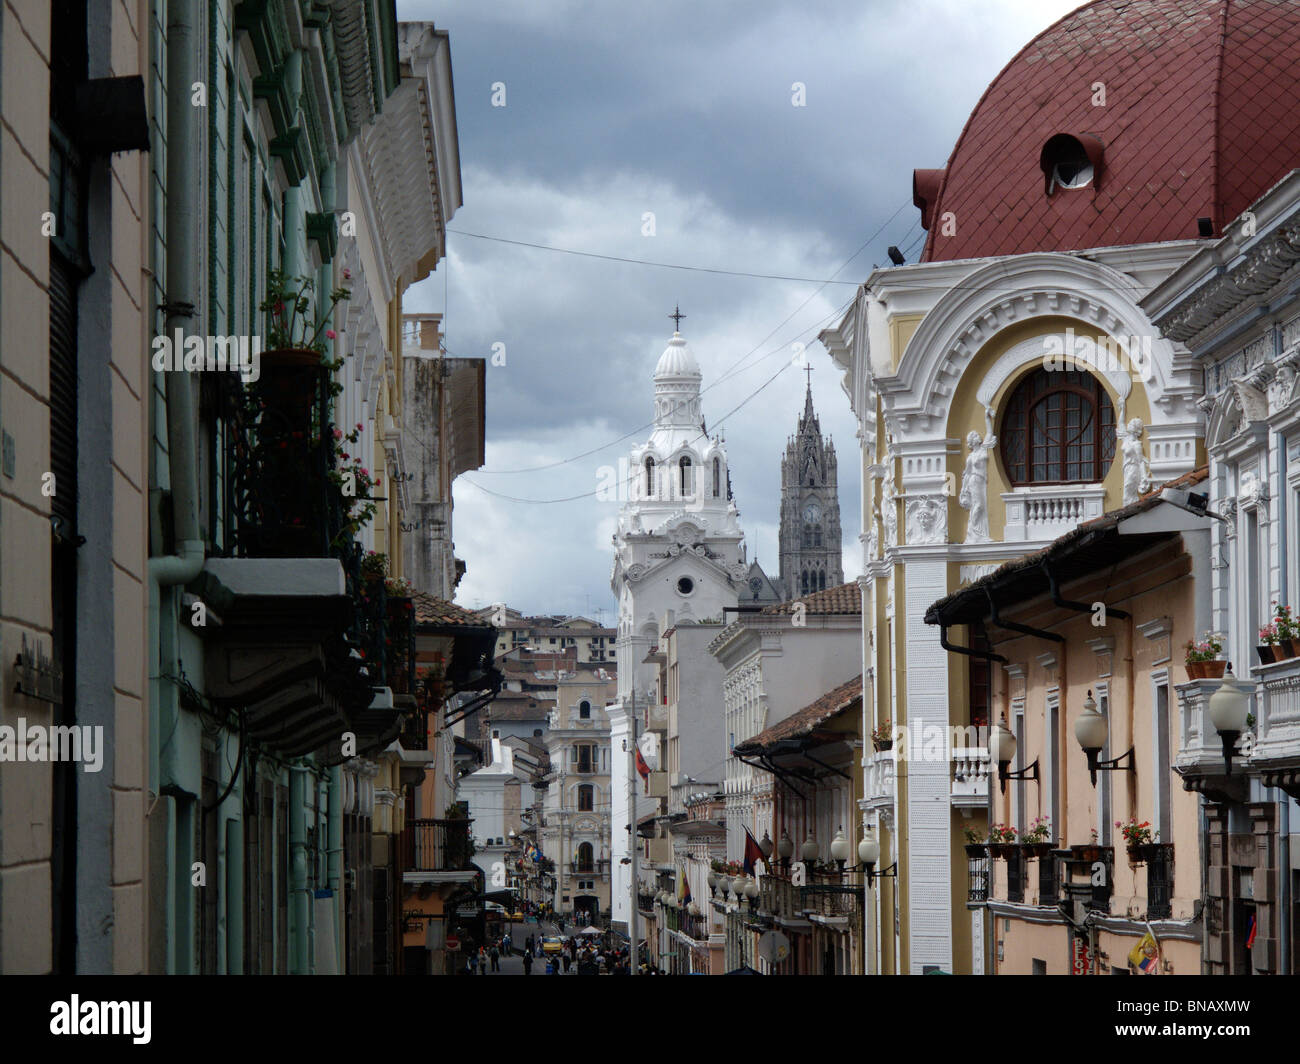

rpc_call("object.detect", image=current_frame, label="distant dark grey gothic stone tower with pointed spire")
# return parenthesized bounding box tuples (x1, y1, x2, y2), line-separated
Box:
(780, 380, 844, 600)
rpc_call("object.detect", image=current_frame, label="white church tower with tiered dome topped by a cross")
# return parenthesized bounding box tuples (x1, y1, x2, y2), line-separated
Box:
(606, 315, 749, 935)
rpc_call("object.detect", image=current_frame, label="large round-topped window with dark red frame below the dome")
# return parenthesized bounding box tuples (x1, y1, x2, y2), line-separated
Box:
(1000, 369, 1115, 485)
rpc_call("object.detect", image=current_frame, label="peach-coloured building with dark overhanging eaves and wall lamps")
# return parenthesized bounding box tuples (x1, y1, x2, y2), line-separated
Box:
(930, 470, 1210, 976)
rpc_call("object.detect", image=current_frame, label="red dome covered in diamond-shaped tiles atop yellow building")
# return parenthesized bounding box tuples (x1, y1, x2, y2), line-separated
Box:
(914, 0, 1300, 261)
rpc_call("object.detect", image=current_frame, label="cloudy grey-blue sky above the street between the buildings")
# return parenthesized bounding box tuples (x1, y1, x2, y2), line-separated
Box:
(398, 0, 1078, 613)
